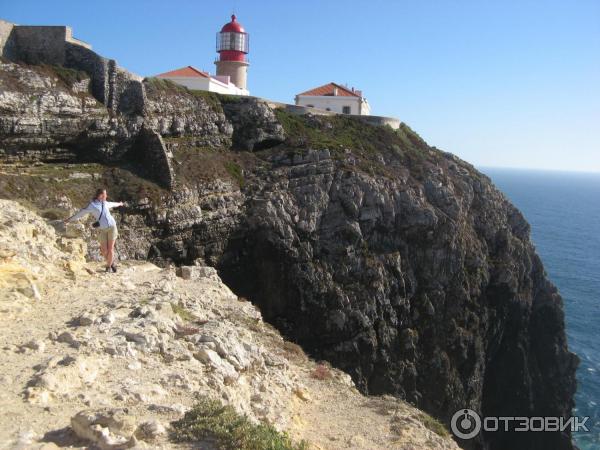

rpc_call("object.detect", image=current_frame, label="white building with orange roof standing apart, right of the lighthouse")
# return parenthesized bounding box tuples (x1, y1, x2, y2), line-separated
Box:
(296, 83, 371, 116)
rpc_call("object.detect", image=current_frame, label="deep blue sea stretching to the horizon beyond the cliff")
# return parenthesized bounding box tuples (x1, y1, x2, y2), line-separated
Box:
(479, 168, 600, 450)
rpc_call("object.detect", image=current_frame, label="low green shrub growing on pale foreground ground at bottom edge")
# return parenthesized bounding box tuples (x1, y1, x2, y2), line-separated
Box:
(171, 397, 308, 450)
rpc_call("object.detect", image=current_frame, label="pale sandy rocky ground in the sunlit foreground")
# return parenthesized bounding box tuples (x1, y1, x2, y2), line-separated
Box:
(0, 200, 458, 449)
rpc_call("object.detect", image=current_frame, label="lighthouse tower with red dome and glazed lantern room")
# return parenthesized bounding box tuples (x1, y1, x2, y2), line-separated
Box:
(215, 14, 249, 90)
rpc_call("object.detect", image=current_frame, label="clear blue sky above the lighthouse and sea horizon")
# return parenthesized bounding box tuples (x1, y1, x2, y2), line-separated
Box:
(0, 0, 600, 172)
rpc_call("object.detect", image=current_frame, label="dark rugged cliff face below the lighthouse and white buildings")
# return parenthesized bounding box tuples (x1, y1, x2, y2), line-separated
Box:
(0, 59, 577, 450)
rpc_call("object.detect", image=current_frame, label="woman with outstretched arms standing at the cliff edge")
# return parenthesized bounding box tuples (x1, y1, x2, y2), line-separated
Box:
(63, 189, 123, 272)
